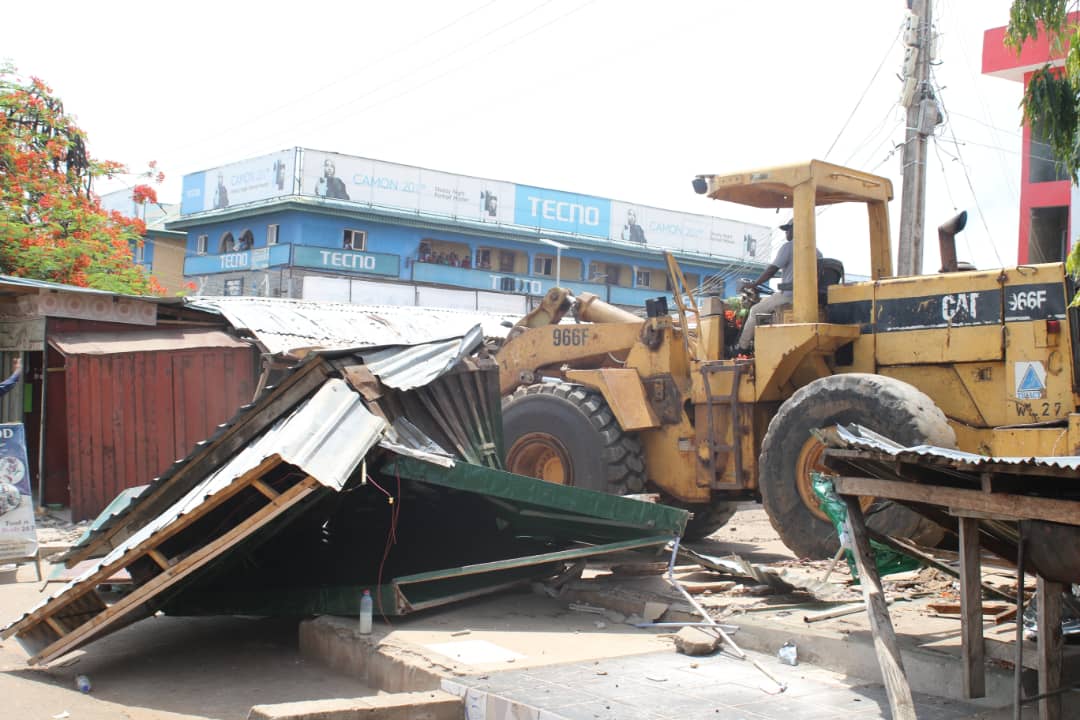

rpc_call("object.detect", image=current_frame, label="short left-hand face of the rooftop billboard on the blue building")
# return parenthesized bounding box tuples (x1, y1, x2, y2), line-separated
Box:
(180, 148, 296, 215)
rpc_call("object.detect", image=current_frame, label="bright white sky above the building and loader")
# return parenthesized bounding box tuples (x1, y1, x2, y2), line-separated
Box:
(0, 0, 1022, 272)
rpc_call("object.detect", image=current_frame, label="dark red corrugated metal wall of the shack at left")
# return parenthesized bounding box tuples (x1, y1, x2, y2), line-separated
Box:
(63, 334, 258, 520)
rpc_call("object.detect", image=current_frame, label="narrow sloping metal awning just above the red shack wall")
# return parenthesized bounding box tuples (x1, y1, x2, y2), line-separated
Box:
(49, 328, 251, 355)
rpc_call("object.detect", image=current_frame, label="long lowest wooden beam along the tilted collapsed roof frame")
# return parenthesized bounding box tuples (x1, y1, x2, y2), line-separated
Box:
(28, 475, 321, 669)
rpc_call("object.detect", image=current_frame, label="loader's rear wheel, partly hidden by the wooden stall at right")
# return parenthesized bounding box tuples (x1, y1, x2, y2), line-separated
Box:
(758, 372, 956, 559)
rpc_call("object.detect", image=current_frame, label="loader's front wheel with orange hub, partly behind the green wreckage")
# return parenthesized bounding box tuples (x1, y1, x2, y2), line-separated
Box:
(502, 382, 645, 495)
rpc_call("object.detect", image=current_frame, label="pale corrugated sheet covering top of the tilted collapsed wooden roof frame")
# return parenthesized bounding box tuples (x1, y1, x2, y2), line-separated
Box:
(0, 379, 387, 631)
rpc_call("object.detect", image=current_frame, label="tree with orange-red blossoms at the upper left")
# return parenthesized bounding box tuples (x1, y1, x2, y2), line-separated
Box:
(0, 66, 163, 295)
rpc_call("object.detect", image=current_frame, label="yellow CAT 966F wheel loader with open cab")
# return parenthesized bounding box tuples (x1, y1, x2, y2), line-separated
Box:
(497, 161, 1080, 558)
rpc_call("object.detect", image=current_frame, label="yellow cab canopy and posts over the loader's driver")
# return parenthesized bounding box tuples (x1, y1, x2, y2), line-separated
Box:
(693, 160, 893, 323)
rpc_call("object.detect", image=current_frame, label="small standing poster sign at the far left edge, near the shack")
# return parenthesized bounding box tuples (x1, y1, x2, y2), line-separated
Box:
(0, 422, 38, 562)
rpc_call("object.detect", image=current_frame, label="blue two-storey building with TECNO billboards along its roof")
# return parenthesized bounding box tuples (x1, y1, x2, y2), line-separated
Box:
(167, 148, 771, 313)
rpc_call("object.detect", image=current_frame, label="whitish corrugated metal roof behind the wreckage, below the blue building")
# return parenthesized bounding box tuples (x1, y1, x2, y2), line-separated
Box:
(187, 297, 519, 354)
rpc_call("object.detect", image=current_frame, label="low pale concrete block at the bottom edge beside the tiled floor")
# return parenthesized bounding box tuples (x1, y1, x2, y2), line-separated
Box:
(247, 690, 465, 720)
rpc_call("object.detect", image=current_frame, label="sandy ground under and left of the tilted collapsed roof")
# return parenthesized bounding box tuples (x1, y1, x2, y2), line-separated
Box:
(0, 507, 375, 720)
